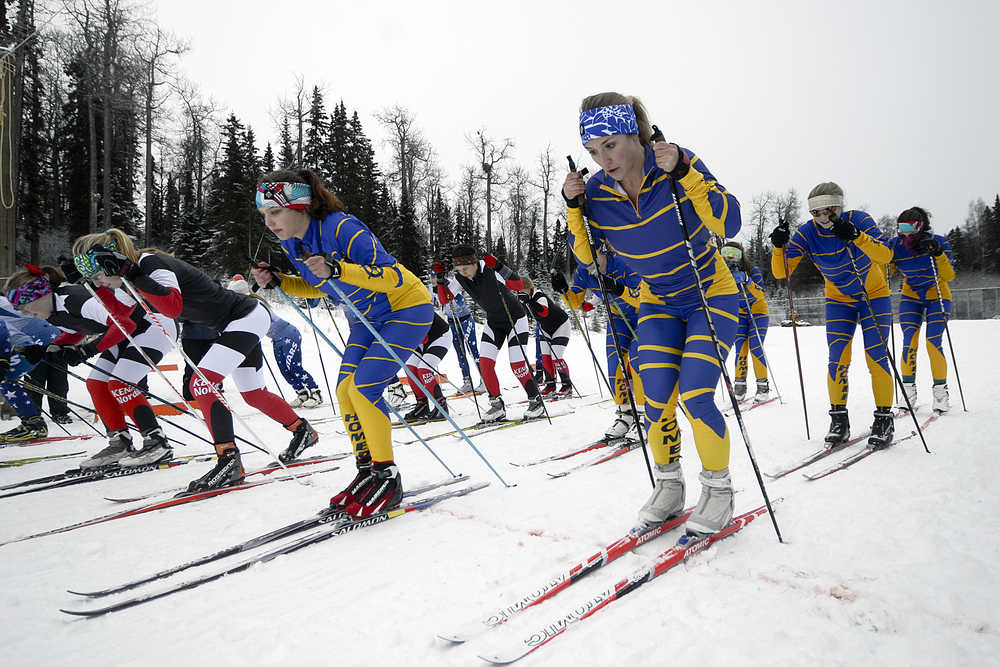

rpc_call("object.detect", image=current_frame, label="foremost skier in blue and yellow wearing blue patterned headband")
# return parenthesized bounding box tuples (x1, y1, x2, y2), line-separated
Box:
(563, 93, 741, 534)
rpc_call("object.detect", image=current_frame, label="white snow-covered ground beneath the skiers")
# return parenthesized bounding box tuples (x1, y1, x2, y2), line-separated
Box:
(0, 312, 1000, 667)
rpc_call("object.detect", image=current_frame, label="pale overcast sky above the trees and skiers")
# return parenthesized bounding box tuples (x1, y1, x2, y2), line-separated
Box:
(156, 0, 1000, 233)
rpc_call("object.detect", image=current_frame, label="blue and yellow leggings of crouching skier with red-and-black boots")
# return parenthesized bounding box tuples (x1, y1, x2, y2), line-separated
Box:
(337, 303, 434, 463)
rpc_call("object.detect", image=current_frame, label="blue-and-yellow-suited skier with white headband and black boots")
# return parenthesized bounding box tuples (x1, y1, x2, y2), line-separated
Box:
(771, 183, 893, 447)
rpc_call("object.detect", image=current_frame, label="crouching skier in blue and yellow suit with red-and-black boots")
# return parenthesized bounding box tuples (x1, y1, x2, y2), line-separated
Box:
(254, 169, 434, 516)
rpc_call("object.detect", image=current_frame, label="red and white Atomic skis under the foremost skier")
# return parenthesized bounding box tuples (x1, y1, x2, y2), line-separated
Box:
(438, 501, 777, 664)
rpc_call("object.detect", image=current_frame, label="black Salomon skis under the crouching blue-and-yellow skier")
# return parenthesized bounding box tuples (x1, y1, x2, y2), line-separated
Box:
(60, 475, 489, 617)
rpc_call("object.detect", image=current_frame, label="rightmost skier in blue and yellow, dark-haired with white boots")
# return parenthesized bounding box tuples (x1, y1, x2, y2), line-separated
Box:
(889, 206, 955, 412)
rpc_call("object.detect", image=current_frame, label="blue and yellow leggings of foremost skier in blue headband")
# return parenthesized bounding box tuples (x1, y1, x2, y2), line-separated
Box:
(638, 294, 739, 470)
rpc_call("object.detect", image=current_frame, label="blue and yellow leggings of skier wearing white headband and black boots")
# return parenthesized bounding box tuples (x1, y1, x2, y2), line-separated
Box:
(826, 296, 893, 406)
